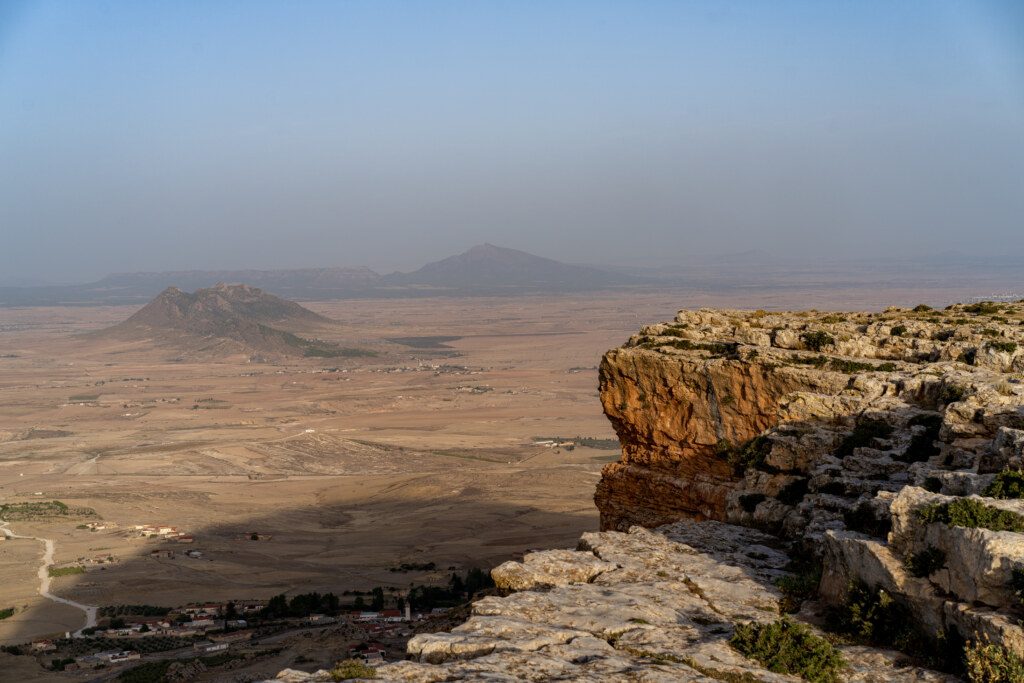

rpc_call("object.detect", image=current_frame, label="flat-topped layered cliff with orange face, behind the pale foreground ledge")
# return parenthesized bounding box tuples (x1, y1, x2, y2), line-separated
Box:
(595, 303, 1024, 653)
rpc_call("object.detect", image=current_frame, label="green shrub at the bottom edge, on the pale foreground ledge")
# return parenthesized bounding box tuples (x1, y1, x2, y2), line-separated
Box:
(729, 617, 846, 683)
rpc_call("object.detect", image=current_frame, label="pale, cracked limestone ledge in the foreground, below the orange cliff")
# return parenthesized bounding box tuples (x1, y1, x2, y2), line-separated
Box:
(264, 521, 952, 683)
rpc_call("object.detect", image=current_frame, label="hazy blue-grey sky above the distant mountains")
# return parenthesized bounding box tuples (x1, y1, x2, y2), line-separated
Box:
(0, 0, 1024, 283)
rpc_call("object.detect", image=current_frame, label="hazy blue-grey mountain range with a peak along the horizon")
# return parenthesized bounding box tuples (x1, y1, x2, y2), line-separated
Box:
(0, 245, 653, 306)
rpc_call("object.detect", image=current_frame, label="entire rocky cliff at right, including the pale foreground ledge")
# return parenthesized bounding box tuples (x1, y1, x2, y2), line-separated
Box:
(266, 302, 1024, 683)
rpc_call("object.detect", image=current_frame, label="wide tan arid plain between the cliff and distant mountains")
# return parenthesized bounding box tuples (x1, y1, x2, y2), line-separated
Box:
(0, 278, 1015, 643)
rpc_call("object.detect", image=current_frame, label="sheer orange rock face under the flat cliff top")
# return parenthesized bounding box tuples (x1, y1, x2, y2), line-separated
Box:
(594, 347, 805, 530)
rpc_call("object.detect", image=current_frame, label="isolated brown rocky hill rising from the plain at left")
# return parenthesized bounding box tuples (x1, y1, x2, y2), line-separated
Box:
(98, 284, 364, 356)
